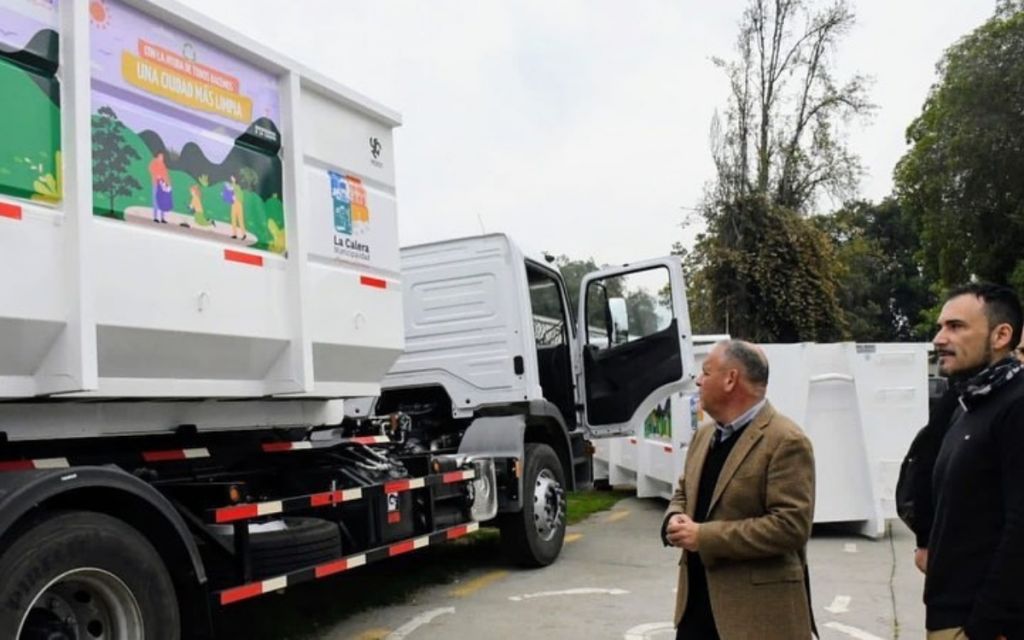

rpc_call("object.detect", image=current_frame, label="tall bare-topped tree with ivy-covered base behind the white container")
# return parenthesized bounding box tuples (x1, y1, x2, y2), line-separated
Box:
(684, 0, 872, 342)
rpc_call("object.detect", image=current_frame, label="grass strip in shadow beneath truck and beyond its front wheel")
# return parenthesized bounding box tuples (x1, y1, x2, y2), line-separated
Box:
(215, 490, 633, 640)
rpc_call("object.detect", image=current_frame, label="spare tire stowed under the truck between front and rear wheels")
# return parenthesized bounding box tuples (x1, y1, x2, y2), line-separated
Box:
(214, 518, 341, 583)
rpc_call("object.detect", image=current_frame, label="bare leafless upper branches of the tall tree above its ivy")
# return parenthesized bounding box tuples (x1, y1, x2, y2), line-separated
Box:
(712, 0, 873, 214)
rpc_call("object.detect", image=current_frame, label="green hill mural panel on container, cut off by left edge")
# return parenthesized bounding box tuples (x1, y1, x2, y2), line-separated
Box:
(0, 0, 62, 204)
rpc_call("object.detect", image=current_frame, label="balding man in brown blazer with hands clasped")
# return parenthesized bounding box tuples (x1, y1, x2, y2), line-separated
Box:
(662, 340, 814, 640)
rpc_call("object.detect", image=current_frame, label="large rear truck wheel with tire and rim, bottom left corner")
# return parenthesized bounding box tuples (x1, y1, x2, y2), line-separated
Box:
(0, 511, 181, 640)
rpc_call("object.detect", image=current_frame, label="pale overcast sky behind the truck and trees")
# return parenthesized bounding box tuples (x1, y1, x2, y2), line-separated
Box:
(174, 0, 994, 264)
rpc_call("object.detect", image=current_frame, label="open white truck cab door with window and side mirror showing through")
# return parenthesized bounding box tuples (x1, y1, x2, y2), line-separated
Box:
(579, 256, 696, 437)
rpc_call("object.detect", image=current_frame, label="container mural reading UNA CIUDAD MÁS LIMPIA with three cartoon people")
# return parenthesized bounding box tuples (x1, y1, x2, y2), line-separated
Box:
(89, 0, 286, 254)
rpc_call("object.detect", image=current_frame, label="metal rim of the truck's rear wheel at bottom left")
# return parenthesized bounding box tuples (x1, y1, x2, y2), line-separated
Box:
(17, 568, 144, 640)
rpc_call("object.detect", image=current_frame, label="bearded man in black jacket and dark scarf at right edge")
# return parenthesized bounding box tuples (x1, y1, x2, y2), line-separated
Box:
(918, 284, 1024, 640)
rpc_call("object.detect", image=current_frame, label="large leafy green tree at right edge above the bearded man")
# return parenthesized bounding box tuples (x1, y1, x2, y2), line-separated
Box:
(895, 0, 1024, 291)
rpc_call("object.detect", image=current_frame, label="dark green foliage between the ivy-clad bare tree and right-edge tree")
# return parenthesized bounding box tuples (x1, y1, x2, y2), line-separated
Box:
(812, 199, 936, 342)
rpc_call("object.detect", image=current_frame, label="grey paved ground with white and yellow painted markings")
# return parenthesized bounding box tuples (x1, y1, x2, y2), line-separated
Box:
(321, 499, 924, 640)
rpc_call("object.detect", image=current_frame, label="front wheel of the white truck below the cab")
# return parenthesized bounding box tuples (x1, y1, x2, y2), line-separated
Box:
(499, 442, 565, 566)
